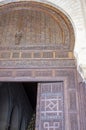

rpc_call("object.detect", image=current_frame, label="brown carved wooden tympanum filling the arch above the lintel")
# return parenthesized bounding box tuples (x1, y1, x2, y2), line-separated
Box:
(0, 1, 74, 51)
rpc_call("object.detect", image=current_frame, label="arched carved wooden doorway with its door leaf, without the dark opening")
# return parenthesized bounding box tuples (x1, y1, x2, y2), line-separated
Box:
(0, 2, 79, 130)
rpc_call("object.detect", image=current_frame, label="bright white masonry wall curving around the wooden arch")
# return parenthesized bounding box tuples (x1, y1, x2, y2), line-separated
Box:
(0, 0, 86, 80)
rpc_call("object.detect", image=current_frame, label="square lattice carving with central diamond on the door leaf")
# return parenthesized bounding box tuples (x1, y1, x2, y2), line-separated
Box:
(41, 93, 62, 118)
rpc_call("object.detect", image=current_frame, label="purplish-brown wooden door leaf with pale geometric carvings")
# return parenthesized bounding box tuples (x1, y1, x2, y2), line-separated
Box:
(38, 82, 64, 130)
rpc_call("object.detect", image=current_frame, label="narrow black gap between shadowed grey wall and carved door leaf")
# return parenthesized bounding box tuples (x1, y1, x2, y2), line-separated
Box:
(22, 82, 37, 130)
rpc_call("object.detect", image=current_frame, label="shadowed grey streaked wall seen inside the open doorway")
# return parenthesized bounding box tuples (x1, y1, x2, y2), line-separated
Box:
(0, 83, 33, 130)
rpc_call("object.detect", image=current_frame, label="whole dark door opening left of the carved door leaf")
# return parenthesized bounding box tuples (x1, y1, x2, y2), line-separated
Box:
(0, 82, 37, 130)
